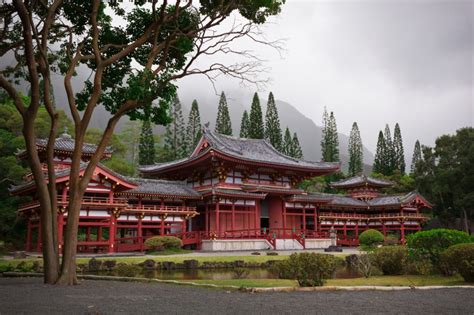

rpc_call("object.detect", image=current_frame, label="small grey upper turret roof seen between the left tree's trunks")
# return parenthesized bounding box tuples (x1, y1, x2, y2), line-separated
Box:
(17, 130, 112, 157)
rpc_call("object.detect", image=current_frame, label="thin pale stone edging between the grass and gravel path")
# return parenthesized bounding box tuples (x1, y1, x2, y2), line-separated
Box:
(3, 272, 474, 293)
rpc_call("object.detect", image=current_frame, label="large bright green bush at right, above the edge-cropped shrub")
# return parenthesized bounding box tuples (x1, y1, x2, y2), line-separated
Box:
(407, 229, 471, 269)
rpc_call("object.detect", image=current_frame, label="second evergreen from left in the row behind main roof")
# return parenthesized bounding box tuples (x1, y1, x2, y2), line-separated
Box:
(165, 96, 188, 160)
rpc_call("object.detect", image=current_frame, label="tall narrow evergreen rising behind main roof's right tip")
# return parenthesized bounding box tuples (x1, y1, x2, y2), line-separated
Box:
(321, 108, 339, 162)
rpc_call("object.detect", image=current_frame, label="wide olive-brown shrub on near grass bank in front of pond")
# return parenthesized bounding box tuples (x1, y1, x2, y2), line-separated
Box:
(272, 253, 338, 287)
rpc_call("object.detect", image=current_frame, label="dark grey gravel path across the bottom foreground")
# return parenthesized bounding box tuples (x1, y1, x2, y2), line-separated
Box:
(0, 278, 474, 315)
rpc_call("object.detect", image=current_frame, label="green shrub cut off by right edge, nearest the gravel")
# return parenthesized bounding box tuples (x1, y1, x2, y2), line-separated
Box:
(441, 243, 474, 282)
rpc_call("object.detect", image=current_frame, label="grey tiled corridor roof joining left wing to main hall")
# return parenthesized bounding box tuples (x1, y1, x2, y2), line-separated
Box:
(122, 177, 201, 199)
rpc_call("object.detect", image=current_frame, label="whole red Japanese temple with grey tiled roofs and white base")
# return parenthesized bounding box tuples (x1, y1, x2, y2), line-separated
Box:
(10, 127, 431, 253)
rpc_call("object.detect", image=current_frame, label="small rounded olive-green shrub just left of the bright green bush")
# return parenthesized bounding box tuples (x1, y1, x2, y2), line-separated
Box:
(373, 246, 408, 275)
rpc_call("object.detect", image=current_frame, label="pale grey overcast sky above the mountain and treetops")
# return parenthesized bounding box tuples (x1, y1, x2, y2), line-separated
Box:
(179, 0, 474, 156)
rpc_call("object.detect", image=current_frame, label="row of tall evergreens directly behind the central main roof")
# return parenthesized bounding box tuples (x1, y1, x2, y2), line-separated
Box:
(138, 92, 303, 165)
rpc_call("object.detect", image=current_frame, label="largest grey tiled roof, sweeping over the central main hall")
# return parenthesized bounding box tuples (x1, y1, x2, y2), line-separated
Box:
(140, 127, 340, 173)
